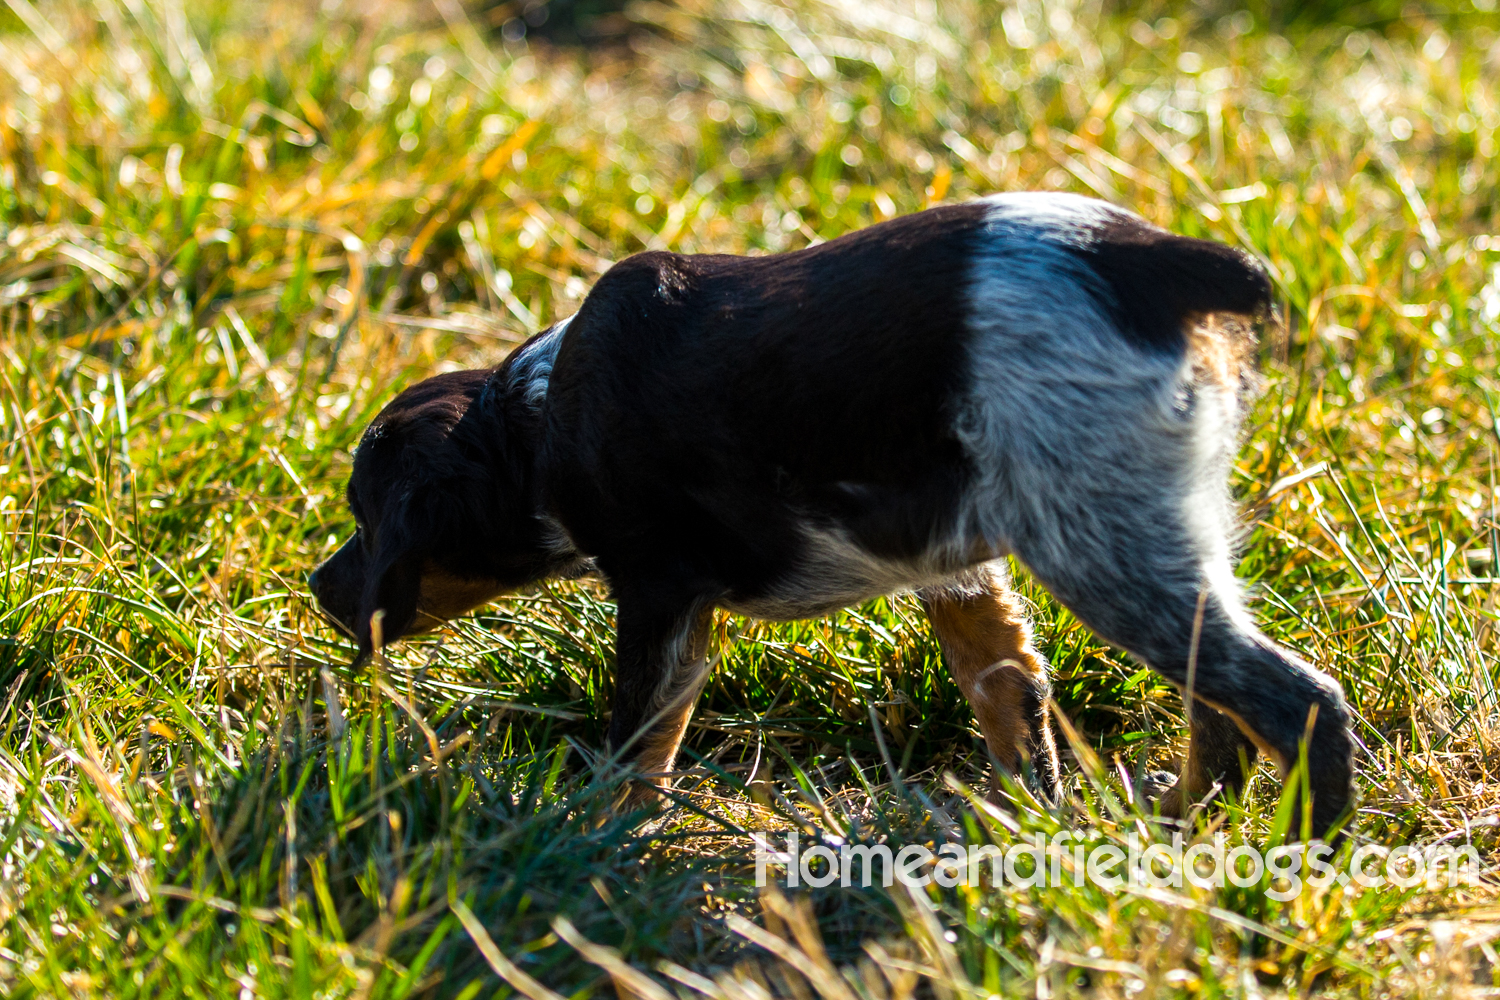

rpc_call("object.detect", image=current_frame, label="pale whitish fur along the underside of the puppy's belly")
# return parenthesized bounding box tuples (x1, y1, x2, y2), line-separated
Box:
(719, 528, 984, 621)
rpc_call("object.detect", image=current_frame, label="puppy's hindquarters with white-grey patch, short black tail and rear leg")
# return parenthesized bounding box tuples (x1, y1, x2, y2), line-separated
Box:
(957, 195, 1352, 831)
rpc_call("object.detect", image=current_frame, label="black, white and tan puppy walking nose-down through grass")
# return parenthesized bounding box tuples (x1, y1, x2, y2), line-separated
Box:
(311, 193, 1353, 834)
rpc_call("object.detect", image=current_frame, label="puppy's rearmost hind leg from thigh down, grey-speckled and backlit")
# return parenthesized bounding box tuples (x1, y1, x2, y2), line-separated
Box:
(1011, 478, 1353, 835)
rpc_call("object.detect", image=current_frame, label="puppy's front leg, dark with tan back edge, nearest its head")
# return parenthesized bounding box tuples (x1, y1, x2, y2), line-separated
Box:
(609, 585, 714, 802)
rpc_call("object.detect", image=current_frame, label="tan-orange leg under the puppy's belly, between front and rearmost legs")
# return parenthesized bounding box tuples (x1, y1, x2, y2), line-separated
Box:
(920, 564, 1058, 799)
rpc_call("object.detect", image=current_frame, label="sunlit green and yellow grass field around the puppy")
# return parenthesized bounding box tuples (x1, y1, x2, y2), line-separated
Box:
(0, 0, 1500, 1000)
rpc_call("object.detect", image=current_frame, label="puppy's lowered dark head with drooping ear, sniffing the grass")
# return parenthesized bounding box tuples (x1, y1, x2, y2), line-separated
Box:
(309, 366, 578, 660)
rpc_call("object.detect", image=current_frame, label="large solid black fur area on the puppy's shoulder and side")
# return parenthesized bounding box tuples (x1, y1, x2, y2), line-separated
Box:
(546, 205, 983, 600)
